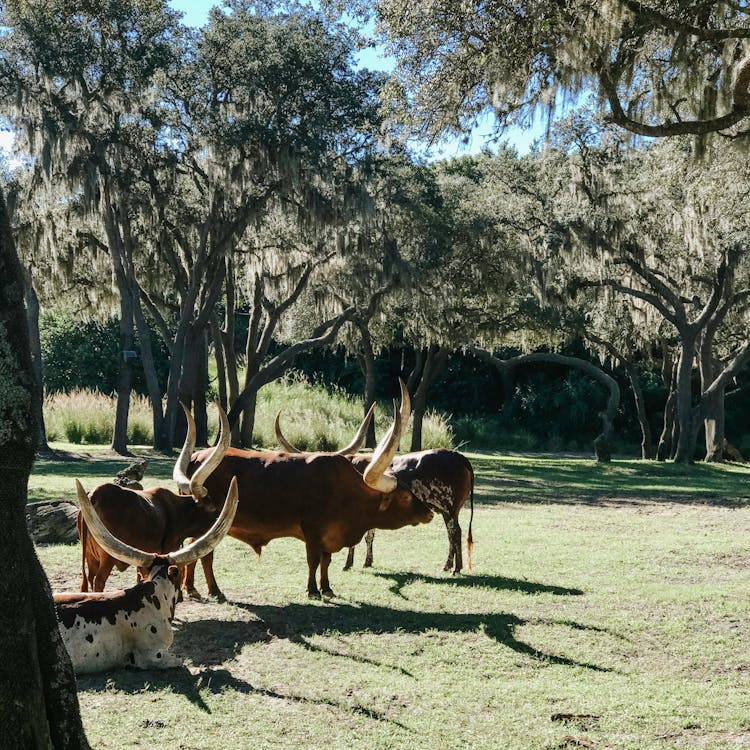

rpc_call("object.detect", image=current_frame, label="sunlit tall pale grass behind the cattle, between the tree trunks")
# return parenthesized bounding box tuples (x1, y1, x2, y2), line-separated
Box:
(44, 375, 454, 451)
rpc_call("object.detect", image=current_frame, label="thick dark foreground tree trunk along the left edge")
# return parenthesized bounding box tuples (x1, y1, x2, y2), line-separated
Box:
(0, 192, 89, 750)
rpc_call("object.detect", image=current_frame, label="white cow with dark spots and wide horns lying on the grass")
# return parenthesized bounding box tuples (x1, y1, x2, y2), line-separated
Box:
(54, 480, 237, 673)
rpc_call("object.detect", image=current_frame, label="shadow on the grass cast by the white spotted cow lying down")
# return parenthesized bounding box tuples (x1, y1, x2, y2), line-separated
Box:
(77, 664, 412, 731)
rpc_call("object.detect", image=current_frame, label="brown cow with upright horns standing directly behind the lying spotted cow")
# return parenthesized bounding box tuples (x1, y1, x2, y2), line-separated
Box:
(76, 407, 231, 591)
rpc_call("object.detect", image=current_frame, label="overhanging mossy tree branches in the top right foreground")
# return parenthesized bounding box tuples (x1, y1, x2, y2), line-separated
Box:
(362, 0, 750, 143)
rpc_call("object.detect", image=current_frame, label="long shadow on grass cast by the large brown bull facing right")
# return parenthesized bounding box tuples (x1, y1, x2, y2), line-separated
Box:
(222, 602, 612, 672)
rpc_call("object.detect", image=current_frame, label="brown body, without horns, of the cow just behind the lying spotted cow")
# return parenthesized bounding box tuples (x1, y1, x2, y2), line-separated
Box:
(76, 482, 217, 592)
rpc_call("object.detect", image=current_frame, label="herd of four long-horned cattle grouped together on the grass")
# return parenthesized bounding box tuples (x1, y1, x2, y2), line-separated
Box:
(54, 383, 474, 672)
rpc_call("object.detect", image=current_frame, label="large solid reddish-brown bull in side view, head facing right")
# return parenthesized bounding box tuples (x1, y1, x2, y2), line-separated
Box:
(183, 383, 432, 597)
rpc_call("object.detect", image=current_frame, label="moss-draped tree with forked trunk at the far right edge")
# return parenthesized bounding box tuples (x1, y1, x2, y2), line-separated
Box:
(542, 126, 750, 462)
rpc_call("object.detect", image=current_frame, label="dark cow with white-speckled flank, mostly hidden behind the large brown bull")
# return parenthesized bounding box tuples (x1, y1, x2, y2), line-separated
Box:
(275, 414, 474, 575)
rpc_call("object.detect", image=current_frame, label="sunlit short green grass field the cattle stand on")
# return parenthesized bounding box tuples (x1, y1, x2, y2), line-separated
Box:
(30, 454, 750, 750)
